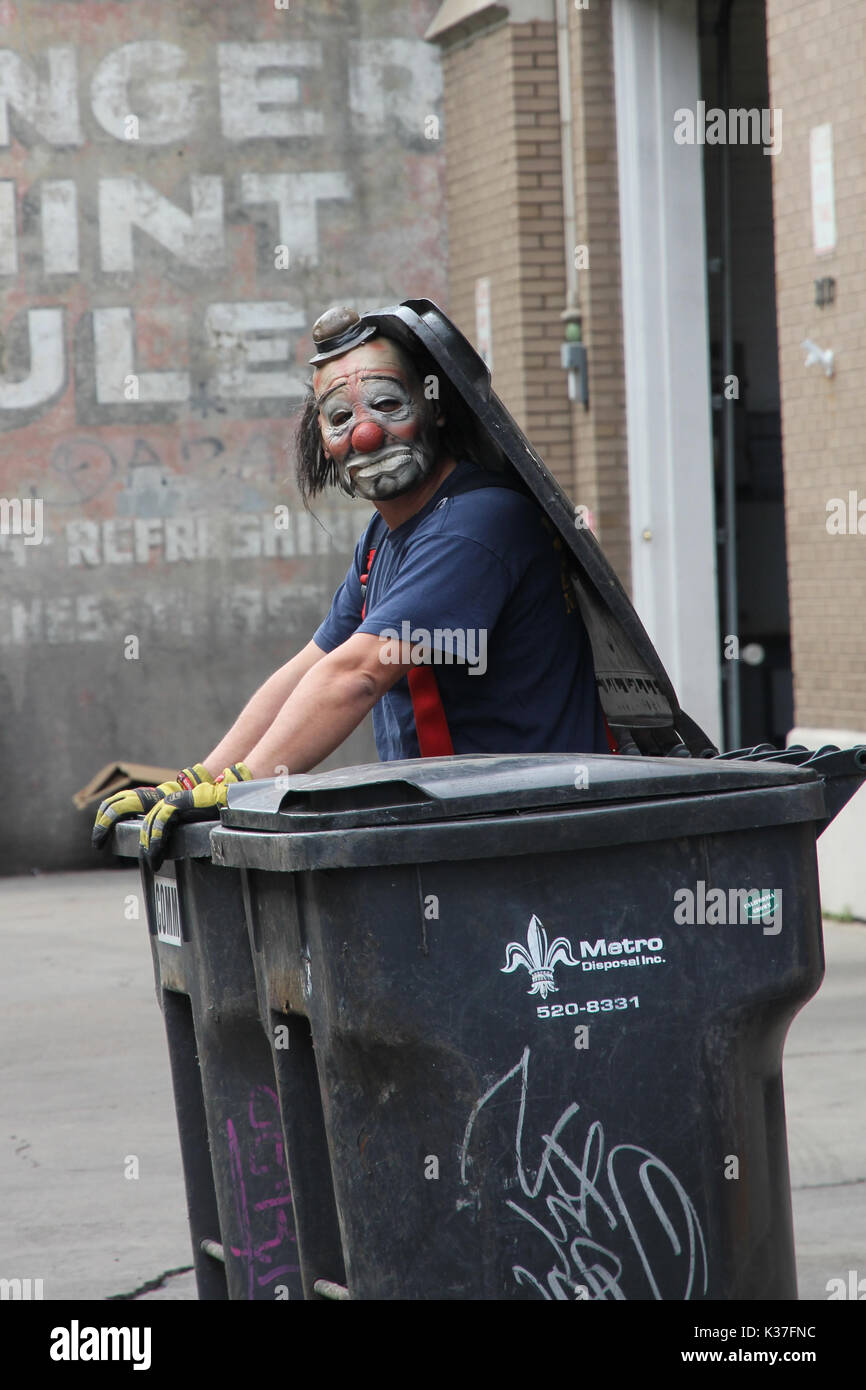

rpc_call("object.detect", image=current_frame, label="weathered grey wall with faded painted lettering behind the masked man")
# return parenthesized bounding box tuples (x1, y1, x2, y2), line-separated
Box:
(0, 0, 446, 872)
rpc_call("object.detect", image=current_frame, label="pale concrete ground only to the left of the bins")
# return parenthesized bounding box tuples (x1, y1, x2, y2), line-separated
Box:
(0, 869, 196, 1300)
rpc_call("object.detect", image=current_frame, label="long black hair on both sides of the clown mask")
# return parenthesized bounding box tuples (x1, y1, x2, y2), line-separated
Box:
(295, 333, 503, 506)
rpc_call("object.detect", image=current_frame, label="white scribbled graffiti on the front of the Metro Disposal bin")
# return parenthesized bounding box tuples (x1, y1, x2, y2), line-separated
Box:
(459, 1047, 709, 1301)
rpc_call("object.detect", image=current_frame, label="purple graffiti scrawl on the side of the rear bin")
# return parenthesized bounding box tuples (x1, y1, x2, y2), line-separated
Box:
(227, 1086, 299, 1298)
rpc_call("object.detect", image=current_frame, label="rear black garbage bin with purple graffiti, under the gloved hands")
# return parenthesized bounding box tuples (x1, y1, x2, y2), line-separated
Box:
(114, 820, 302, 1301)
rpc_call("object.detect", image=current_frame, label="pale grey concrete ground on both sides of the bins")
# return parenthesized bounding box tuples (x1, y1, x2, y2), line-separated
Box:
(0, 869, 866, 1300)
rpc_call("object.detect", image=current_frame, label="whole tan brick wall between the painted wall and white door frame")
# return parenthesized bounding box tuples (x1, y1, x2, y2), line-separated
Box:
(430, 7, 628, 592)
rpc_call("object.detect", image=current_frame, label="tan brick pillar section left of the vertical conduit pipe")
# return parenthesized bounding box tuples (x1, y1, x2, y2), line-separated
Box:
(443, 22, 571, 488)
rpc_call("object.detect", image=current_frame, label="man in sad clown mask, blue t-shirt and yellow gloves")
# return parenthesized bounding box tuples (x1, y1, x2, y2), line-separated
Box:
(93, 306, 609, 867)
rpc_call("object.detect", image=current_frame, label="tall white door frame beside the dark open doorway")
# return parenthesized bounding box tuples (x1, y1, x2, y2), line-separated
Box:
(613, 0, 721, 744)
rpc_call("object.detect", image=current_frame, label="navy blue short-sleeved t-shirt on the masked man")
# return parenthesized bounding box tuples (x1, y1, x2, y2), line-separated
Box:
(313, 461, 609, 762)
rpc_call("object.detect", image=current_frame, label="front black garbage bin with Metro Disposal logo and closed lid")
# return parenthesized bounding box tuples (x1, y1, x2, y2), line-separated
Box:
(211, 749, 866, 1300)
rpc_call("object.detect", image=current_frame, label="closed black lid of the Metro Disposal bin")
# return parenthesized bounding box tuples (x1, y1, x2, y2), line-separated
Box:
(221, 753, 820, 834)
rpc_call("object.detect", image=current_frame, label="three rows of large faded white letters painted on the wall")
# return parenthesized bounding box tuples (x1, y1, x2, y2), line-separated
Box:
(0, 27, 439, 430)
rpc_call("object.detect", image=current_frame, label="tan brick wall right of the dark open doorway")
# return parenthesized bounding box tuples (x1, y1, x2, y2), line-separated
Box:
(767, 0, 866, 728)
